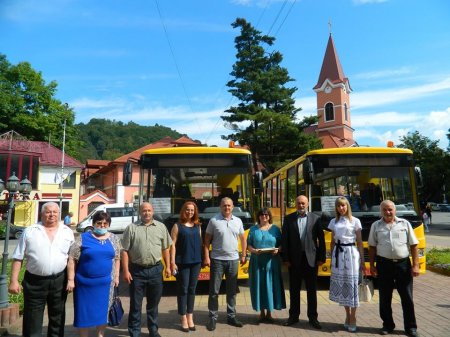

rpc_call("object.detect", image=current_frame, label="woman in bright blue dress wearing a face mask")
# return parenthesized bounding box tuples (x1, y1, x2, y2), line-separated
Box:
(67, 212, 121, 337)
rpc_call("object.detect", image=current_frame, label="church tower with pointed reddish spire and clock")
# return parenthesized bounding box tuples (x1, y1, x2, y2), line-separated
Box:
(313, 33, 356, 148)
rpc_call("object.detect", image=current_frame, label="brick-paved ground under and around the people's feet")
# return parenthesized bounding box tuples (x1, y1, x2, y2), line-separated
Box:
(4, 272, 450, 337)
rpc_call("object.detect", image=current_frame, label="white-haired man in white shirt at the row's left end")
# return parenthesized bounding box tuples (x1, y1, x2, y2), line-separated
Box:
(9, 202, 74, 337)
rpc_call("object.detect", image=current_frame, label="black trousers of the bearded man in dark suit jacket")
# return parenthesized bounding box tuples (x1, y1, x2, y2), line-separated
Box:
(289, 253, 318, 320)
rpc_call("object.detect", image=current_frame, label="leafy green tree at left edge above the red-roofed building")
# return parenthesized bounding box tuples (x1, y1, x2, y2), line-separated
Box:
(0, 54, 82, 157)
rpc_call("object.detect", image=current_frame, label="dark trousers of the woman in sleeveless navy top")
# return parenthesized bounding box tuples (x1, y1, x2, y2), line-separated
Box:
(177, 263, 201, 315)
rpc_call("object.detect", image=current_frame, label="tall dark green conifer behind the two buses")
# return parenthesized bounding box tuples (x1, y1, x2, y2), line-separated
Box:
(221, 18, 321, 172)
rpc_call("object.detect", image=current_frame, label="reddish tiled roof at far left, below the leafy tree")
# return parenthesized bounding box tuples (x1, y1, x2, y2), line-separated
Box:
(0, 139, 84, 168)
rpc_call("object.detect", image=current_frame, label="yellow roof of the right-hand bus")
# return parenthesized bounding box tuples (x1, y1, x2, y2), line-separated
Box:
(264, 146, 413, 180)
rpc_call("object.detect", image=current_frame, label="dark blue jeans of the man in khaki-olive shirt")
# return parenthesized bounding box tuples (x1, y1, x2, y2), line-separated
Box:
(128, 264, 163, 337)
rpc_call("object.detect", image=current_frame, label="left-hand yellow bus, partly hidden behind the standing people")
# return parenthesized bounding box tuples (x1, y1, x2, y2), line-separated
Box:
(124, 146, 255, 281)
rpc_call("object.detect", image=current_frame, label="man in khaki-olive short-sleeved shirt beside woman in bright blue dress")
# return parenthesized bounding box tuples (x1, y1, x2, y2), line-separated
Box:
(122, 202, 172, 337)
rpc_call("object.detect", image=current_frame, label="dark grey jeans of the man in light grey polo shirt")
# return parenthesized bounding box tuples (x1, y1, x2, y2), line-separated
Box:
(208, 259, 239, 320)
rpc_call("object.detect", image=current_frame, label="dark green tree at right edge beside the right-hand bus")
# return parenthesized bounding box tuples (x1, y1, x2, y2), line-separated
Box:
(399, 131, 450, 202)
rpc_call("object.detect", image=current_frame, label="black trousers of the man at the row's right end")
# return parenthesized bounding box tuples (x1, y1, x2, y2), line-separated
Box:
(377, 256, 417, 331)
